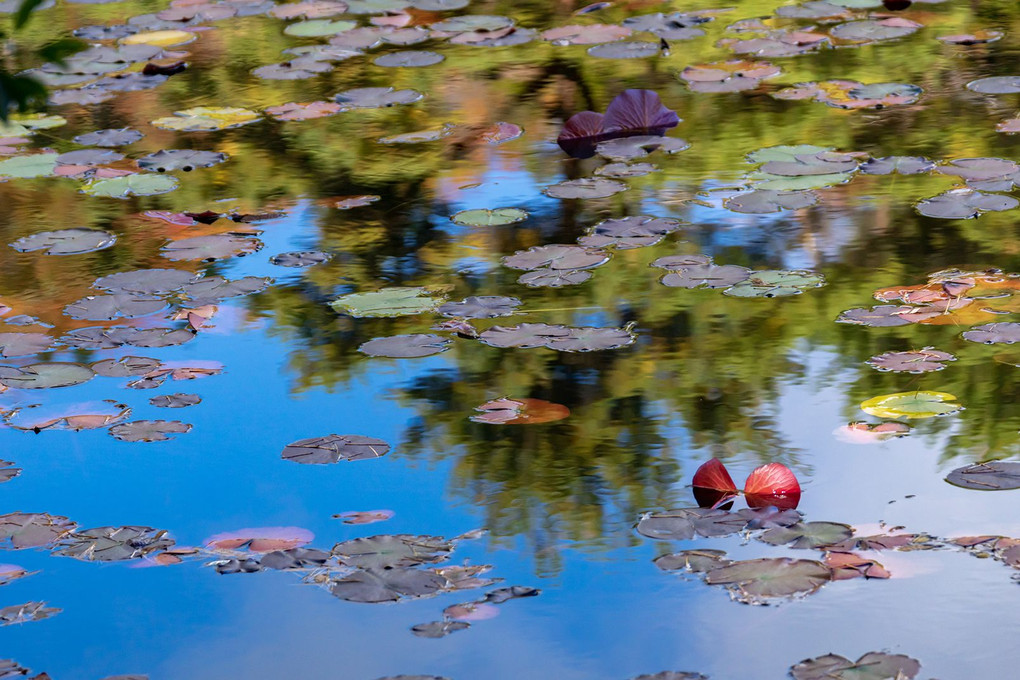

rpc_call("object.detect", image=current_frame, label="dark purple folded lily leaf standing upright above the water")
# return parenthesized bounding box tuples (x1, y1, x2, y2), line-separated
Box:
(556, 90, 680, 158)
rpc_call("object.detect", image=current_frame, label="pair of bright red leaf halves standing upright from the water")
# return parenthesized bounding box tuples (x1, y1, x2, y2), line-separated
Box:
(693, 458, 801, 510)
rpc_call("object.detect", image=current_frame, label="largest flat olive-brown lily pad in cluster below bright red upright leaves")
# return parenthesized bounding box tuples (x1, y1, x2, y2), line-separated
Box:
(705, 558, 832, 604)
